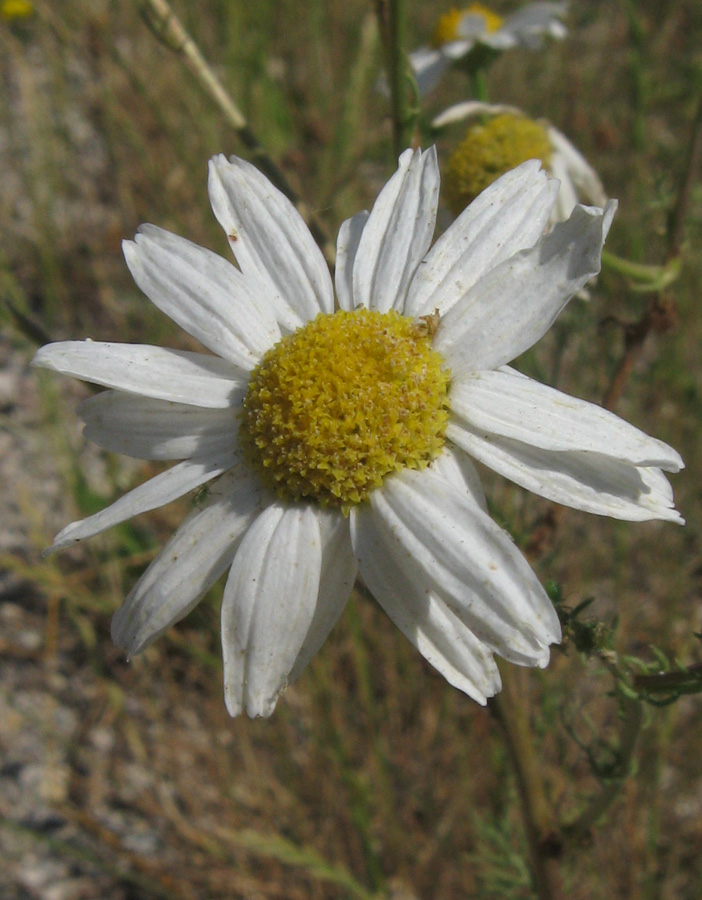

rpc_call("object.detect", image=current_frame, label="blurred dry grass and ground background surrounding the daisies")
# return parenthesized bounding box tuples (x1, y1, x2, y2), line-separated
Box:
(0, 0, 702, 900)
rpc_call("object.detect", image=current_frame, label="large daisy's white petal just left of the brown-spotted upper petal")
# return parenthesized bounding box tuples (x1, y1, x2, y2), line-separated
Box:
(123, 225, 280, 371)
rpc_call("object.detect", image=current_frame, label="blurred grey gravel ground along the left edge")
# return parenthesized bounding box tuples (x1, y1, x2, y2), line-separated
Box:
(0, 334, 158, 900)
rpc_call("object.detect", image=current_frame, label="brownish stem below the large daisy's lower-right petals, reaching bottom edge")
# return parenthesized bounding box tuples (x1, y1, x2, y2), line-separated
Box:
(489, 667, 565, 900)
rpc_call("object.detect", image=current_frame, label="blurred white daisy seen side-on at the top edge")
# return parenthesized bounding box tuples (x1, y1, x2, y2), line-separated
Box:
(409, 3, 568, 96)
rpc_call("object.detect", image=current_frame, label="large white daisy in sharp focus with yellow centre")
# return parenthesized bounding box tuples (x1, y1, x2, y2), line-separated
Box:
(34, 148, 682, 716)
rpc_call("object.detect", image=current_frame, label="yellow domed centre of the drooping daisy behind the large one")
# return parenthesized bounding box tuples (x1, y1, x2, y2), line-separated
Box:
(443, 113, 552, 215)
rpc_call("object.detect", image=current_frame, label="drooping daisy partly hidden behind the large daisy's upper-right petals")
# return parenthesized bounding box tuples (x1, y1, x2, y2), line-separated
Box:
(432, 100, 607, 224)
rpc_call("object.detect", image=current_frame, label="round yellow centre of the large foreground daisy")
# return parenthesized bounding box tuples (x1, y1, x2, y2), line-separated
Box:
(239, 309, 450, 512)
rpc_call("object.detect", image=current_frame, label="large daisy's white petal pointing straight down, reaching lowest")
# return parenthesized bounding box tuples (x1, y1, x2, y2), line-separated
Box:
(222, 502, 322, 716)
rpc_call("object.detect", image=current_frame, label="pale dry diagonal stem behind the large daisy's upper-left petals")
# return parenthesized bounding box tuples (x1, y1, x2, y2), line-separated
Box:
(142, 0, 334, 263)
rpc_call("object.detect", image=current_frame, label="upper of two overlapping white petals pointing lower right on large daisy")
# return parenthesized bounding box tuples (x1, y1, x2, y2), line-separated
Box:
(368, 470, 560, 663)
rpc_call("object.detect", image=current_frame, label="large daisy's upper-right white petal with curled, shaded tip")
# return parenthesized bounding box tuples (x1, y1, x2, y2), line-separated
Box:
(434, 201, 616, 377)
